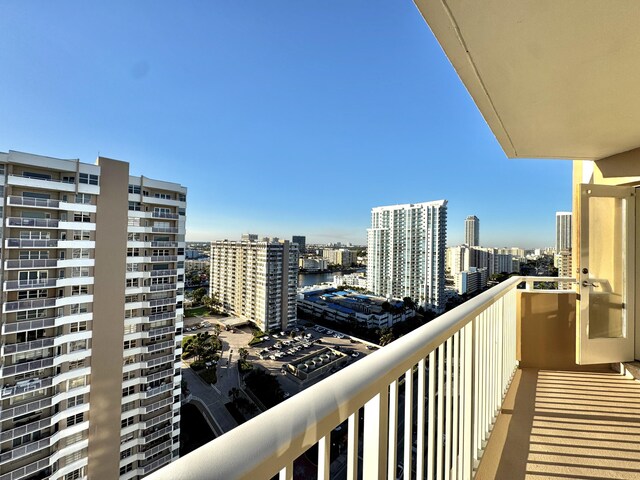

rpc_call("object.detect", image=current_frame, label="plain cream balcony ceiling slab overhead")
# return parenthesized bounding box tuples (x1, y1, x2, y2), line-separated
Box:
(414, 0, 640, 160)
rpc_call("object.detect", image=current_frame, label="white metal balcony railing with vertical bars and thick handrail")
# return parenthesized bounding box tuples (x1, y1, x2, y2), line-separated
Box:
(148, 277, 573, 480)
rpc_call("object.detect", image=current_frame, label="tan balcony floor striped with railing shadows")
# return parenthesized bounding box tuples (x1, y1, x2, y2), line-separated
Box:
(476, 368, 640, 480)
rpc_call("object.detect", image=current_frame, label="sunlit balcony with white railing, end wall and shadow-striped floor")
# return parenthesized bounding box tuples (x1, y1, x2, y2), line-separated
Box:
(149, 277, 640, 480)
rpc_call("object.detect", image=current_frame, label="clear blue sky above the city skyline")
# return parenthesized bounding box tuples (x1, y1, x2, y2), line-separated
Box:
(0, 0, 571, 248)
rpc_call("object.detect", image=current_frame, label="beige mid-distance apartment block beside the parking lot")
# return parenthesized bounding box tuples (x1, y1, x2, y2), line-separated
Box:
(209, 240, 298, 332)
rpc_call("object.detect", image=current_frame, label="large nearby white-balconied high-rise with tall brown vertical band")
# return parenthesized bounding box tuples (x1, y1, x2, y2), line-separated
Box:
(0, 151, 186, 480)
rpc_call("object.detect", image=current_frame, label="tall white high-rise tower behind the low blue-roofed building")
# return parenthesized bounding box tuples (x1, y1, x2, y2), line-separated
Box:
(367, 200, 447, 312)
